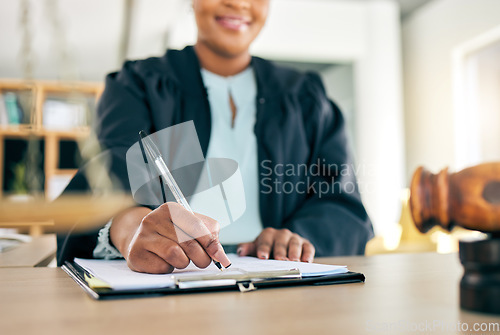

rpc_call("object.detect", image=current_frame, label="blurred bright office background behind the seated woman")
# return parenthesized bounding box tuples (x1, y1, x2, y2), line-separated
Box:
(0, 0, 500, 254)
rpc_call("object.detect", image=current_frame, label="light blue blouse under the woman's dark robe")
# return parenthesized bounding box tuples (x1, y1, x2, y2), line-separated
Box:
(190, 67, 263, 244)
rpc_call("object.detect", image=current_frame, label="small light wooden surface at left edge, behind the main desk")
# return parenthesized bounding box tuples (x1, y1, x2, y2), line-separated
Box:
(0, 234, 57, 270)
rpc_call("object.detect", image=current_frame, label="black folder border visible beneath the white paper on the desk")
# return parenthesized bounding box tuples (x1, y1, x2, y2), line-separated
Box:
(62, 262, 365, 300)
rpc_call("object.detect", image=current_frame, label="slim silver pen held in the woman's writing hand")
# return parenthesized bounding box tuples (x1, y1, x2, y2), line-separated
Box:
(139, 130, 231, 271)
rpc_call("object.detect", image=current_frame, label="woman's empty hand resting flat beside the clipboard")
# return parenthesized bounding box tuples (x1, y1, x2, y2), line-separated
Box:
(237, 228, 315, 263)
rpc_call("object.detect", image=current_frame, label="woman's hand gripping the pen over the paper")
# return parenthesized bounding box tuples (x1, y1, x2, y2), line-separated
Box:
(110, 202, 231, 273)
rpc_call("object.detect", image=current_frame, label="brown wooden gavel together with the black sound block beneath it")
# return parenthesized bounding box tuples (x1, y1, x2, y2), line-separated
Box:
(410, 163, 500, 314)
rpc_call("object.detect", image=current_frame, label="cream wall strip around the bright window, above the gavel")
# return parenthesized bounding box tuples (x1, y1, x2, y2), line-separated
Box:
(403, 0, 500, 179)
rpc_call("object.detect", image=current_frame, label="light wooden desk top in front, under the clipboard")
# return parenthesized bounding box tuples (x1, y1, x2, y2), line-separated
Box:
(0, 254, 500, 335)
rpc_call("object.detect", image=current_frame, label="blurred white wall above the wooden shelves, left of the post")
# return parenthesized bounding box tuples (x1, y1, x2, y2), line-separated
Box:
(0, 0, 122, 81)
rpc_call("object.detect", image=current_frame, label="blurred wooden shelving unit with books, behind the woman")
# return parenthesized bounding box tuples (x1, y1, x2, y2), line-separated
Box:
(0, 80, 104, 197)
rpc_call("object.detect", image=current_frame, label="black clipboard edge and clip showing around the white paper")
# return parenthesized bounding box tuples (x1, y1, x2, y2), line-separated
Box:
(61, 261, 365, 300)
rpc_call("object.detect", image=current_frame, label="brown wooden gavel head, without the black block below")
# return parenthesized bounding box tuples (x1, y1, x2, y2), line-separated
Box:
(410, 162, 500, 235)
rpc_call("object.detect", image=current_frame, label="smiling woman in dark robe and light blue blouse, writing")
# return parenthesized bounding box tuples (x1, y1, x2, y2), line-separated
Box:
(59, 0, 373, 273)
